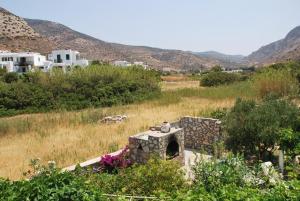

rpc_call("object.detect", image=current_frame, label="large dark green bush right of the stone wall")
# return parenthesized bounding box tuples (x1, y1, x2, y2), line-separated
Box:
(225, 98, 300, 160)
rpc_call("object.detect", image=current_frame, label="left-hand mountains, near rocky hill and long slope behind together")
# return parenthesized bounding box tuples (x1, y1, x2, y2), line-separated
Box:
(0, 8, 219, 70)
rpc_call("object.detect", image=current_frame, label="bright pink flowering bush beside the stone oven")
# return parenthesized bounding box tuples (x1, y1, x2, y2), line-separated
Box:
(100, 147, 131, 173)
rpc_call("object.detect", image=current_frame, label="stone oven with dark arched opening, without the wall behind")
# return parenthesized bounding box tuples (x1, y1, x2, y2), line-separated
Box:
(129, 127, 184, 163)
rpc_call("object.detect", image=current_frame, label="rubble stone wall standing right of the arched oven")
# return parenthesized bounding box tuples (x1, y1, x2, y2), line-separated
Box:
(179, 116, 221, 153)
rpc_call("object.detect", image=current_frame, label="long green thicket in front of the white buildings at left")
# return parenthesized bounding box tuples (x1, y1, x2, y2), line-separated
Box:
(0, 65, 160, 116)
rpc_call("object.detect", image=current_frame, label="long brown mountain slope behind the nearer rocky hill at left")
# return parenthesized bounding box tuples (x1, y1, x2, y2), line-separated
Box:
(25, 19, 218, 70)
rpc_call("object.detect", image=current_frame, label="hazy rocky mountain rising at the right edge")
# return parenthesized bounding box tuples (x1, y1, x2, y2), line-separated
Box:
(247, 26, 300, 65)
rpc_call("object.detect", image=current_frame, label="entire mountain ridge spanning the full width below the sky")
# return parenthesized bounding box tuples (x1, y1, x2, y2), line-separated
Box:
(0, 7, 300, 71)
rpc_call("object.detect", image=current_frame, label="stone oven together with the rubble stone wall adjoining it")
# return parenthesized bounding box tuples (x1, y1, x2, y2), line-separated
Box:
(129, 116, 221, 163)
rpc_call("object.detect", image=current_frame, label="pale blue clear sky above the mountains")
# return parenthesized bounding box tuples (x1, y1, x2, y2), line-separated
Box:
(0, 0, 300, 55)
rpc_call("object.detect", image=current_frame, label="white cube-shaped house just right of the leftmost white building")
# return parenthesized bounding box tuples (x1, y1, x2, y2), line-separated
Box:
(48, 50, 89, 70)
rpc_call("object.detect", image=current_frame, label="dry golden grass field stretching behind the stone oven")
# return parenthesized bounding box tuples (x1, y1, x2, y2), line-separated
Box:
(0, 82, 253, 179)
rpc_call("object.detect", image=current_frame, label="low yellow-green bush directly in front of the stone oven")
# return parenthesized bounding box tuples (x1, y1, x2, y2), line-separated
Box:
(92, 159, 186, 196)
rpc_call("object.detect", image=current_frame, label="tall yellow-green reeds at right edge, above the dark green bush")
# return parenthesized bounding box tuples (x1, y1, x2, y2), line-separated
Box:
(253, 68, 299, 97)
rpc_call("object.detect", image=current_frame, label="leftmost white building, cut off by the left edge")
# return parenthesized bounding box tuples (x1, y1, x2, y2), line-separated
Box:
(0, 52, 51, 73)
